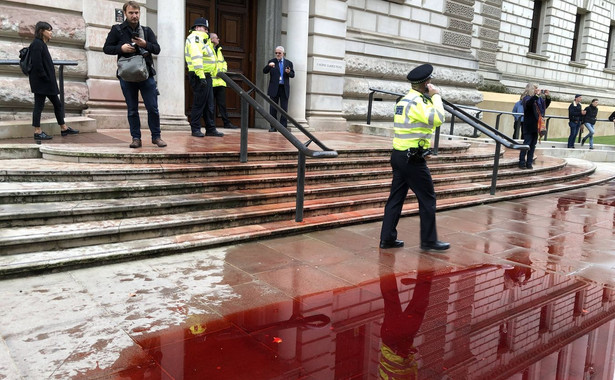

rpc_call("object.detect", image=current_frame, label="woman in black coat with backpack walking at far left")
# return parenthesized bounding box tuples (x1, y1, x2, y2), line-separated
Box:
(29, 21, 79, 140)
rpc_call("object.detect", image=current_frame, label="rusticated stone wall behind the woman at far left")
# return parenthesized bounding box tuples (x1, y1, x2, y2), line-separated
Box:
(0, 0, 89, 120)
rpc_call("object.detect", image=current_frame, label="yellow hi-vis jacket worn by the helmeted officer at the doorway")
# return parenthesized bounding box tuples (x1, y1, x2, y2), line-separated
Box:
(184, 30, 216, 79)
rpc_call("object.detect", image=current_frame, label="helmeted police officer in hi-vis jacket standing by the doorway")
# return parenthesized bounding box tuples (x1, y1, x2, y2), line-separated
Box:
(184, 17, 224, 137)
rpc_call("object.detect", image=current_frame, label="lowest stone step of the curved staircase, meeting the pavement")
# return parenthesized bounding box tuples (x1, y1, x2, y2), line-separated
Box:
(0, 168, 612, 277)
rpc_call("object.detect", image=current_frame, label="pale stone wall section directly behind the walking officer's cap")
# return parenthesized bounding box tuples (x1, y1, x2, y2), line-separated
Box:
(343, 0, 483, 127)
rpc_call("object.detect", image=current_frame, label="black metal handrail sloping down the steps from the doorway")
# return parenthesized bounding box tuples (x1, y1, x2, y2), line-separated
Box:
(218, 72, 337, 222)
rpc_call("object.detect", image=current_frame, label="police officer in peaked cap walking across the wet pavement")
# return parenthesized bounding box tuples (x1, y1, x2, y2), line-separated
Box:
(380, 64, 450, 251)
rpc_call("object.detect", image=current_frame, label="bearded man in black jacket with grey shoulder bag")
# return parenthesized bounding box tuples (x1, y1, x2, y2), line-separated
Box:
(103, 1, 167, 148)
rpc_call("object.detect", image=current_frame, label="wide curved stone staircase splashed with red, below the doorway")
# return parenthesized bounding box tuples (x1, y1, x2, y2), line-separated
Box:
(0, 133, 611, 277)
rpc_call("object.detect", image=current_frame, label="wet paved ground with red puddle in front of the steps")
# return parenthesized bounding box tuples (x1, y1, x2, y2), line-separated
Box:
(0, 174, 615, 380)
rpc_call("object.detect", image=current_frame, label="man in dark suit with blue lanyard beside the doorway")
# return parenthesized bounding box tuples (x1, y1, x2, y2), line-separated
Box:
(263, 46, 295, 132)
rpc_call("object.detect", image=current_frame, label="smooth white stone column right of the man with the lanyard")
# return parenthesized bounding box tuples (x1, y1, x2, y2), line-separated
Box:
(285, 0, 310, 125)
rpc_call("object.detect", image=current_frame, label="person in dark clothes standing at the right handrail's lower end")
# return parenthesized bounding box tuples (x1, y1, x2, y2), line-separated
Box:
(519, 83, 551, 169)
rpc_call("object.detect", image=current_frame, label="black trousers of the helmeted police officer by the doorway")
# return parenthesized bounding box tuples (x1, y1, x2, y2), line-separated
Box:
(188, 71, 216, 132)
